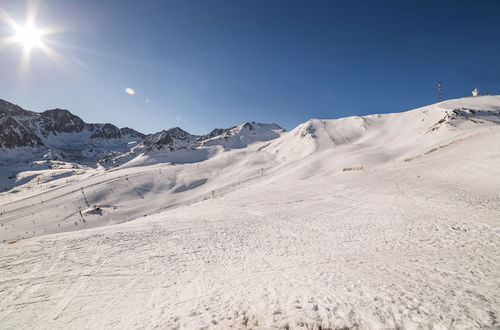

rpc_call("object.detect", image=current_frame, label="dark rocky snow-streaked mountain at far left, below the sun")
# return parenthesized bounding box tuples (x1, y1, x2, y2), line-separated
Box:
(0, 100, 145, 161)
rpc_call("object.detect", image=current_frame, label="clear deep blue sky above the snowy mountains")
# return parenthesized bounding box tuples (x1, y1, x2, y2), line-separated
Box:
(0, 0, 500, 133)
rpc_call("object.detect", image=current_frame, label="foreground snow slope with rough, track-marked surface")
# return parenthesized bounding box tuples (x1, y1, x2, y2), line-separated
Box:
(0, 164, 500, 329)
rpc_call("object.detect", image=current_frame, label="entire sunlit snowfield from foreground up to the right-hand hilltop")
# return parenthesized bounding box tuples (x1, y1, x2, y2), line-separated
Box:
(0, 96, 500, 329)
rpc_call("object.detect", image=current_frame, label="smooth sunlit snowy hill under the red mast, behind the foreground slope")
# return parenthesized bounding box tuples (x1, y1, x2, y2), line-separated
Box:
(266, 96, 500, 178)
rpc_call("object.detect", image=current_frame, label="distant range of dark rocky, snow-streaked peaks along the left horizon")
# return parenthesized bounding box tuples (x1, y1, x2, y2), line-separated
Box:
(0, 100, 284, 166)
